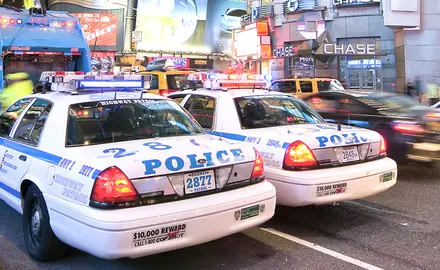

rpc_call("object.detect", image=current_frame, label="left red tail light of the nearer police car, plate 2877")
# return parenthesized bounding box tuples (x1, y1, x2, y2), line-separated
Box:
(91, 166, 139, 203)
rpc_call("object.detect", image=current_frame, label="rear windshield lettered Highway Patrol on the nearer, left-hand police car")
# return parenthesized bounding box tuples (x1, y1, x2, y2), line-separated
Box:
(66, 99, 204, 146)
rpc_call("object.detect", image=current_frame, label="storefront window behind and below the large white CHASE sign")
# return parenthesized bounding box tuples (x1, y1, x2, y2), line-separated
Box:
(338, 38, 383, 91)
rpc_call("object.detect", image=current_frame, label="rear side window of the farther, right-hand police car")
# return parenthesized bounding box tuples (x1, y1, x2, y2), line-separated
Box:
(184, 95, 215, 129)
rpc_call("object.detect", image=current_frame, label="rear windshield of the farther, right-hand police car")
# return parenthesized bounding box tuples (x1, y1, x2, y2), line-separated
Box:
(235, 95, 325, 129)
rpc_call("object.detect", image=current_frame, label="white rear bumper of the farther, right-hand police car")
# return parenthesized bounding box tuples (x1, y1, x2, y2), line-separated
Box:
(266, 158, 397, 206)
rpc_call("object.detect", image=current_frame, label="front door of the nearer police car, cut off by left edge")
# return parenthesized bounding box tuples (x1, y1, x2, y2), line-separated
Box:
(0, 98, 34, 202)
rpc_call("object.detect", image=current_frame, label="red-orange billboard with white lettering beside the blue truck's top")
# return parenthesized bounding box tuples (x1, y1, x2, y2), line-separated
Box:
(73, 13, 117, 50)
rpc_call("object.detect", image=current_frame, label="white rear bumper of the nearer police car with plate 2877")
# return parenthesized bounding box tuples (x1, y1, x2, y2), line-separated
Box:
(44, 181, 276, 259)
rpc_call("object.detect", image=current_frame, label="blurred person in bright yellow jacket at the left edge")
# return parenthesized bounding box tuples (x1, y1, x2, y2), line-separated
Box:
(0, 72, 34, 110)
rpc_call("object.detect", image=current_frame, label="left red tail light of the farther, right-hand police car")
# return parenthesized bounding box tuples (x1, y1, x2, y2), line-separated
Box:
(283, 141, 318, 170)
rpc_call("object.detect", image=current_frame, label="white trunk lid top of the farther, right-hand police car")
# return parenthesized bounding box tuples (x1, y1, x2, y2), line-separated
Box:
(247, 123, 380, 150)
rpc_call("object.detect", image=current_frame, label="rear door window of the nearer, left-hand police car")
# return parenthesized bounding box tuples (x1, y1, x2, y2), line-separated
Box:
(14, 99, 52, 145)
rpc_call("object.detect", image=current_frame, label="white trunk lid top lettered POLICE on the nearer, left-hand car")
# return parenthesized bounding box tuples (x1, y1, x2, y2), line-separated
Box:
(71, 135, 255, 179)
